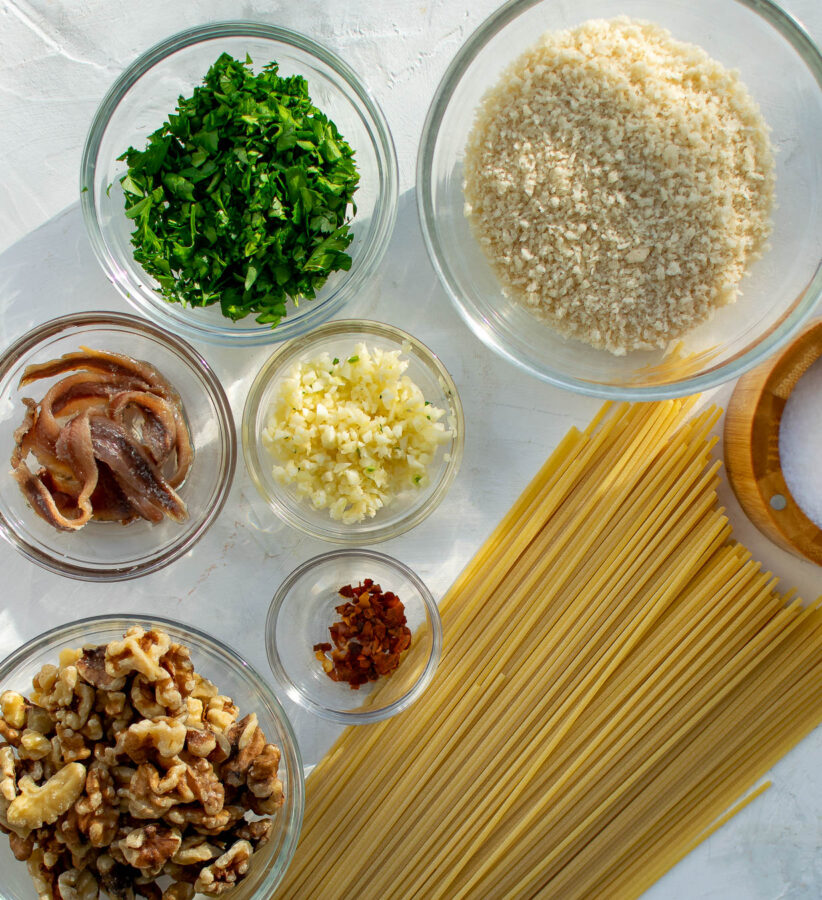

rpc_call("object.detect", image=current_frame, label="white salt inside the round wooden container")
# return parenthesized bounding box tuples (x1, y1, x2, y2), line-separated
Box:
(779, 360, 822, 528)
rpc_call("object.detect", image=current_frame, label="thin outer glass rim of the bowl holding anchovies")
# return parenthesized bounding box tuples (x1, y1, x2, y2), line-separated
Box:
(0, 311, 237, 582)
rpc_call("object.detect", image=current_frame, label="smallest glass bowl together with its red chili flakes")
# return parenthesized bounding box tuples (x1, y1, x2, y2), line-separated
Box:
(265, 549, 442, 725)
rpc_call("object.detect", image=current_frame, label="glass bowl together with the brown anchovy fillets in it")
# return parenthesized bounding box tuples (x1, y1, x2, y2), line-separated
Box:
(0, 311, 237, 582)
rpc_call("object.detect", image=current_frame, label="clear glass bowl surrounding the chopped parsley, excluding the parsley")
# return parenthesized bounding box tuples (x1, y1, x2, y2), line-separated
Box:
(80, 22, 398, 346)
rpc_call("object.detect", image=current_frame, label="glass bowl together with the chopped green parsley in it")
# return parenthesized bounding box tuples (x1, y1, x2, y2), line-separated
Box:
(80, 22, 398, 346)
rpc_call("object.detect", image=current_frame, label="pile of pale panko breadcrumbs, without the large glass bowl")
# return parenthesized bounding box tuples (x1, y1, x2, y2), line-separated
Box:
(465, 17, 774, 355)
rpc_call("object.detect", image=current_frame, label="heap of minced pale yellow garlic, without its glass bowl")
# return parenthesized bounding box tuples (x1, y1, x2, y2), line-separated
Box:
(262, 344, 452, 524)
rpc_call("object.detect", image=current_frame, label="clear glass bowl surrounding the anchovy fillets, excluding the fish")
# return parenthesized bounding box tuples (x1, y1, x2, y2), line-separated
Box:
(0, 312, 237, 581)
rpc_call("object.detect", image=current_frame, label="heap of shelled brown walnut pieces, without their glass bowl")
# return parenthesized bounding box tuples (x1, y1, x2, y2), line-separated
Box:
(0, 627, 283, 900)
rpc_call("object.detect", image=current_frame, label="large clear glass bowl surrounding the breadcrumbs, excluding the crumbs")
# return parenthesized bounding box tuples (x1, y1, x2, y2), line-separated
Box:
(417, 0, 822, 400)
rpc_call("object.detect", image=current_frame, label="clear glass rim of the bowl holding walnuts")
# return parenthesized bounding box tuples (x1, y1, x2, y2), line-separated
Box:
(0, 613, 305, 895)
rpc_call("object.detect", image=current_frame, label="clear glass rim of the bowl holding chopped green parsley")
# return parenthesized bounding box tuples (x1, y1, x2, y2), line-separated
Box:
(80, 19, 399, 347)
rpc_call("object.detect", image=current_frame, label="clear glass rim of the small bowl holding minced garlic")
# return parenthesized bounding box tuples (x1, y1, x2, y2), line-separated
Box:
(241, 319, 465, 546)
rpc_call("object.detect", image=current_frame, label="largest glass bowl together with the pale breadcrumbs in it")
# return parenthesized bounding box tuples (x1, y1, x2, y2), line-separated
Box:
(418, 0, 822, 399)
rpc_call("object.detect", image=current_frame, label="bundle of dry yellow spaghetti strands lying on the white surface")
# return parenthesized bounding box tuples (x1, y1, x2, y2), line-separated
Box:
(281, 401, 822, 900)
